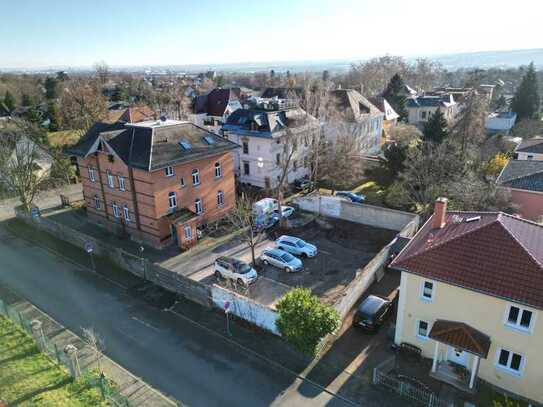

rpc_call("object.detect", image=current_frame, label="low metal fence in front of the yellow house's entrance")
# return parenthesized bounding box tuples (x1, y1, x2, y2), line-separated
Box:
(373, 360, 450, 407)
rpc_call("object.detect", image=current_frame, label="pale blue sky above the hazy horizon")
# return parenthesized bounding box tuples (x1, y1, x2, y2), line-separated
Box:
(0, 0, 543, 68)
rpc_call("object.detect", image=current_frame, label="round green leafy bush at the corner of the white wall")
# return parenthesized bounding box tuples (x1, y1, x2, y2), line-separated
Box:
(277, 288, 341, 355)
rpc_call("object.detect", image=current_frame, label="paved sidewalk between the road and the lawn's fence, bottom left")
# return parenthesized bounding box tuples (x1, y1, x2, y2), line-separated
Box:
(0, 284, 179, 407)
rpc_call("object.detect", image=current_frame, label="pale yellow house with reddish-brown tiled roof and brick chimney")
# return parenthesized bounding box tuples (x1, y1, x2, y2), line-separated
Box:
(391, 198, 543, 403)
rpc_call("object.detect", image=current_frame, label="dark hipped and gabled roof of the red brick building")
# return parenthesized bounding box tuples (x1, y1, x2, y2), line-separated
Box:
(69, 121, 238, 171)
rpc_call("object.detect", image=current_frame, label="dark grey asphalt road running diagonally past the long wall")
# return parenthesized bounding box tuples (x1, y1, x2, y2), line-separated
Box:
(0, 226, 349, 406)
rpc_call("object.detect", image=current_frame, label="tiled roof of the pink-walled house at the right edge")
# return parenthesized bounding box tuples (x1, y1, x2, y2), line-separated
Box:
(497, 160, 543, 192)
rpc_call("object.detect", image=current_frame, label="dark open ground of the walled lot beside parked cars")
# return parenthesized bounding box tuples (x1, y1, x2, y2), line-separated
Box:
(258, 219, 397, 303)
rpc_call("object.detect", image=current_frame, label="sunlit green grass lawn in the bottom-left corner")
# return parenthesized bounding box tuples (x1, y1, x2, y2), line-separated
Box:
(0, 316, 107, 407)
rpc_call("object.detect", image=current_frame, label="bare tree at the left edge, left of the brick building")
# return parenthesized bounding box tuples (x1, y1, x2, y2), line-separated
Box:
(0, 122, 54, 209)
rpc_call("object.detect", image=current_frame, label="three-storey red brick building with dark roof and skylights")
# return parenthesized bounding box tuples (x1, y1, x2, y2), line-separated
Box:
(70, 120, 238, 248)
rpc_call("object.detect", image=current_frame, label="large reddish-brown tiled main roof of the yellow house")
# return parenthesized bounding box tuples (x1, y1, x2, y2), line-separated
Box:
(391, 212, 543, 309)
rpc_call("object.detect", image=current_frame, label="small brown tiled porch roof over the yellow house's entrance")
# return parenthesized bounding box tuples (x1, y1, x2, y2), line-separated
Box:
(429, 319, 490, 359)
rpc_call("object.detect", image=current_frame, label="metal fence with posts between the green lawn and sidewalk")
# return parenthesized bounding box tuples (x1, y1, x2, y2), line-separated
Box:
(0, 299, 130, 407)
